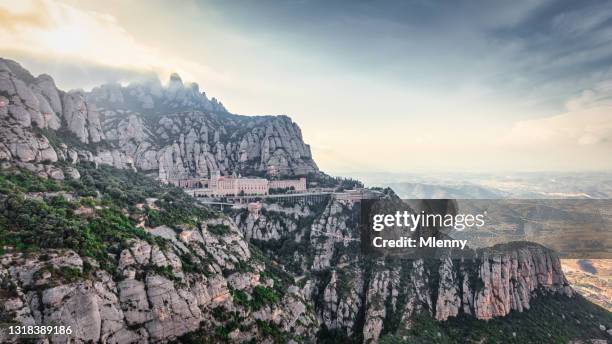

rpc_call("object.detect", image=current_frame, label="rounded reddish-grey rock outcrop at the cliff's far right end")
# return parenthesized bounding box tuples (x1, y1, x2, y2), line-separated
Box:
(436, 243, 574, 320)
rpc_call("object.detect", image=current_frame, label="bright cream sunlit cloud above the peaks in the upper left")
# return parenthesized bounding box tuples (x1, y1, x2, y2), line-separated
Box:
(0, 0, 223, 85)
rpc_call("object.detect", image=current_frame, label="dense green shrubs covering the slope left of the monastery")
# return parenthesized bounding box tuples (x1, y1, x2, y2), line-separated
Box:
(0, 163, 212, 272)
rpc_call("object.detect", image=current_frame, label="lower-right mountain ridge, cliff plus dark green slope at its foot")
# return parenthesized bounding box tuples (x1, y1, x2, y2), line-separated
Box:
(233, 198, 611, 343)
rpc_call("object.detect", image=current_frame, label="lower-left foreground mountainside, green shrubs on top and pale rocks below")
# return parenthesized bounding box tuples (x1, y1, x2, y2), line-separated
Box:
(0, 166, 318, 344)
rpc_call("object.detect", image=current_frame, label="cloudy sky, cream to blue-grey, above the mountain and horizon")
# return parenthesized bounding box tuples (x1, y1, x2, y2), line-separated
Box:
(0, 0, 612, 174)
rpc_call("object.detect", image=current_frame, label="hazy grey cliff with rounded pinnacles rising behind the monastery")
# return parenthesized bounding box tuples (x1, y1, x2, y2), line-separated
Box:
(0, 59, 317, 179)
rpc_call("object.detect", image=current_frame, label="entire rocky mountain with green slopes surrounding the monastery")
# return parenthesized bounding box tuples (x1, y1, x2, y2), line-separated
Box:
(0, 60, 612, 343)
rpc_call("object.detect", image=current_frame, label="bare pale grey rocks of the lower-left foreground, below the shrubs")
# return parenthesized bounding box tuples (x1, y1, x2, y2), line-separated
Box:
(0, 220, 316, 343)
